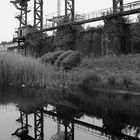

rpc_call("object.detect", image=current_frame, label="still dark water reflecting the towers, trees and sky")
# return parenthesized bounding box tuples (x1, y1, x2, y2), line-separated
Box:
(0, 87, 140, 140)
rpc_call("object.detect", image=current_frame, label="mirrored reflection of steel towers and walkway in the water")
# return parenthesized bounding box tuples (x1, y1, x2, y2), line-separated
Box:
(12, 107, 139, 140)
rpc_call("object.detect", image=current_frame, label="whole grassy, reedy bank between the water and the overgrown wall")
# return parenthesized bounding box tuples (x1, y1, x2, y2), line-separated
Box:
(0, 53, 140, 92)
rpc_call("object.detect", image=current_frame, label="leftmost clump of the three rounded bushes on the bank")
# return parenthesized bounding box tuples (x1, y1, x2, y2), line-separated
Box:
(39, 51, 63, 64)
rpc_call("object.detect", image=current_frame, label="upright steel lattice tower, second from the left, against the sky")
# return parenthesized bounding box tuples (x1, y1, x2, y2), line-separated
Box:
(34, 0, 43, 30)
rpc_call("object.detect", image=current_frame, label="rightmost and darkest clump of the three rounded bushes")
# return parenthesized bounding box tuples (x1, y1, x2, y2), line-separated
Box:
(61, 51, 81, 70)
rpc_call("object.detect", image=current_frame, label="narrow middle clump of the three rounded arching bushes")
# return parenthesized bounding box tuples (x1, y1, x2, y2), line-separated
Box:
(55, 50, 73, 66)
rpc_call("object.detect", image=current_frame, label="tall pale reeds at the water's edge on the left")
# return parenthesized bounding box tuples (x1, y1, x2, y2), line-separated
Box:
(0, 53, 64, 87)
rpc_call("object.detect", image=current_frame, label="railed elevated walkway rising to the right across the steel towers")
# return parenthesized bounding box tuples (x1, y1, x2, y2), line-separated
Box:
(43, 1, 140, 32)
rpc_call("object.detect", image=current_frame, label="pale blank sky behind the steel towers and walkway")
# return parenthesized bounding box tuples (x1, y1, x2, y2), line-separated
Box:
(0, 0, 136, 42)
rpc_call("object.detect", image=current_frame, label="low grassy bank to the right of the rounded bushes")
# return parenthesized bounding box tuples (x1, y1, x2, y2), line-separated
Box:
(65, 55, 140, 91)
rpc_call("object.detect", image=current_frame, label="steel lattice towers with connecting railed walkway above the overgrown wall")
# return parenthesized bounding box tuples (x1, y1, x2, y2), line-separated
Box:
(7, 0, 140, 55)
